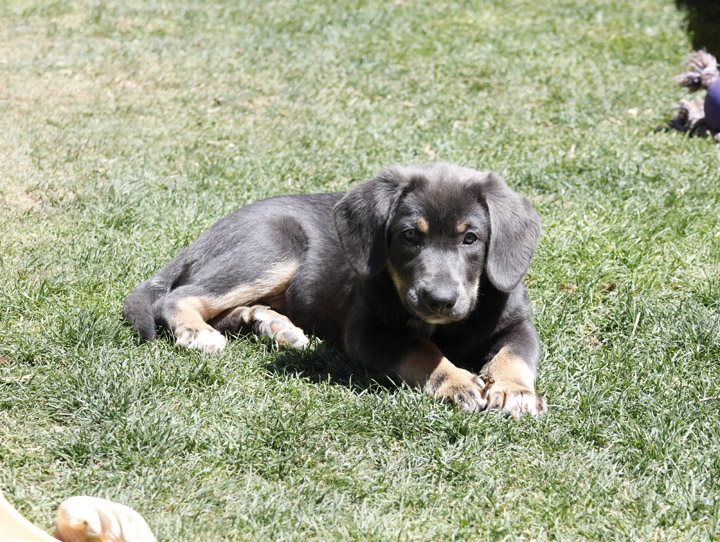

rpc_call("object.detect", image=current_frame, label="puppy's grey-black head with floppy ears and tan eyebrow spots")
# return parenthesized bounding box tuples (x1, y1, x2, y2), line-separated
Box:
(333, 163, 540, 324)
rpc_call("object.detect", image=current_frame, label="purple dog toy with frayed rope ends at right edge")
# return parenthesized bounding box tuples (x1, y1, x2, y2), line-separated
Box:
(670, 51, 720, 141)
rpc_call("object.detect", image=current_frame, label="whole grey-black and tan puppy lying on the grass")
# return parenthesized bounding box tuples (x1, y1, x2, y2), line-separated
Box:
(124, 163, 546, 417)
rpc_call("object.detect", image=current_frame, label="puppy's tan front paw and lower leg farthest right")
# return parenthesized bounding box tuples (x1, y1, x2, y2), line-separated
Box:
(482, 346, 547, 418)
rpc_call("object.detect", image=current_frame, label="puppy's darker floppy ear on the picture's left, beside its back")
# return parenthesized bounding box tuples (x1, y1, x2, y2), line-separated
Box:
(333, 167, 407, 277)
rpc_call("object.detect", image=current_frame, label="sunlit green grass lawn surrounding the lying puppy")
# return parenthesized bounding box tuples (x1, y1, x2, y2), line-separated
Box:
(0, 0, 720, 541)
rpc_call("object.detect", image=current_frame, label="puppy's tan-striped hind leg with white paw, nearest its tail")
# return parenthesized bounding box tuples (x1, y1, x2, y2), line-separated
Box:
(168, 261, 299, 353)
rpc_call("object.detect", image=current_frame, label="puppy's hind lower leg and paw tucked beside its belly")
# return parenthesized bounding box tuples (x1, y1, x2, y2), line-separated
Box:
(211, 305, 310, 350)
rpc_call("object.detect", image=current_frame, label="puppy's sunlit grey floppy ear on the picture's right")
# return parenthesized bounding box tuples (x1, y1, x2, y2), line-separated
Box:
(482, 173, 540, 292)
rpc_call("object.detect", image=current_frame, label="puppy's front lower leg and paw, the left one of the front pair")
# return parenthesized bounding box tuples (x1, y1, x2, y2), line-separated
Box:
(397, 341, 486, 412)
